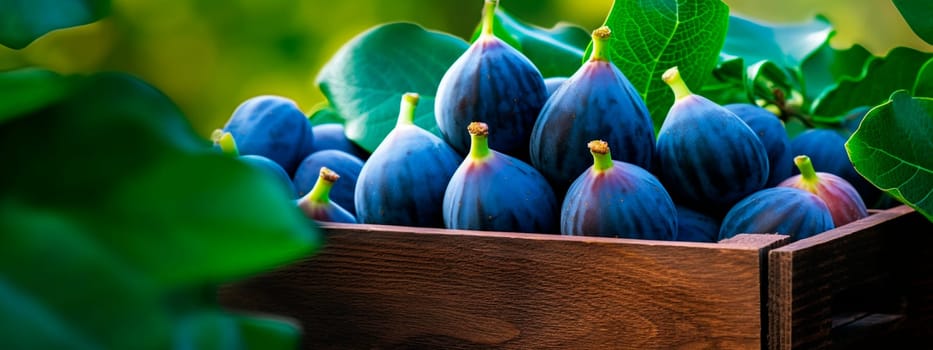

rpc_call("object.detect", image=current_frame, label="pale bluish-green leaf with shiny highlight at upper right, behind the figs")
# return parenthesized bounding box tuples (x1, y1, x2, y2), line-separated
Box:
(722, 15, 833, 69)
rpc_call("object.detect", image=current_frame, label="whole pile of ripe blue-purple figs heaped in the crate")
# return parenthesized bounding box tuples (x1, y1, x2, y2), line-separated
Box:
(213, 0, 876, 242)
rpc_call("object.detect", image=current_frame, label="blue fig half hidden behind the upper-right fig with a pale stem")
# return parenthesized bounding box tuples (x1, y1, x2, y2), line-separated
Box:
(723, 103, 794, 187)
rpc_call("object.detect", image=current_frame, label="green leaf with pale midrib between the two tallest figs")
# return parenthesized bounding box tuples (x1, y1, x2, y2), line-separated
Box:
(470, 5, 590, 78)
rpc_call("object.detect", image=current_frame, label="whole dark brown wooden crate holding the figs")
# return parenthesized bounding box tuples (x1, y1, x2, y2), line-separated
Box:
(219, 206, 933, 349)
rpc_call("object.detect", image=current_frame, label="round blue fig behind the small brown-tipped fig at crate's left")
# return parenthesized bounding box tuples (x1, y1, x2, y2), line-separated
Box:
(292, 148, 364, 215)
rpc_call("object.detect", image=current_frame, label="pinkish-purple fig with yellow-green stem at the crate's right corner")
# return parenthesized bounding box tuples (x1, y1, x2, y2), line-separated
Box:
(778, 155, 868, 227)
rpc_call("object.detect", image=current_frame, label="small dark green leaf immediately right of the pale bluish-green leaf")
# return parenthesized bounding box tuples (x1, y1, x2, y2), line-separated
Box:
(800, 41, 874, 101)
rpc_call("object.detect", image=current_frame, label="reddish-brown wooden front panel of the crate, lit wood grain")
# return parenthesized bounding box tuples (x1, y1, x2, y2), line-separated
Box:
(219, 224, 786, 349)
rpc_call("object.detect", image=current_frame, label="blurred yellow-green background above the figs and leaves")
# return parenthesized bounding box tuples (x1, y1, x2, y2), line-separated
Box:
(0, 0, 933, 137)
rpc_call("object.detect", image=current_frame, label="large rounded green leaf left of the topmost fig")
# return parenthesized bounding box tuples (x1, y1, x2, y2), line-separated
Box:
(316, 23, 469, 152)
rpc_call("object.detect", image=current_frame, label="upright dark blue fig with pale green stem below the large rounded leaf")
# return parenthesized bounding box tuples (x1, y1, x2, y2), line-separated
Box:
(354, 92, 463, 227)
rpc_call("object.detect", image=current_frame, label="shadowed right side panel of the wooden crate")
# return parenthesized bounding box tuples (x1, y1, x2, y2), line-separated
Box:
(768, 206, 933, 349)
